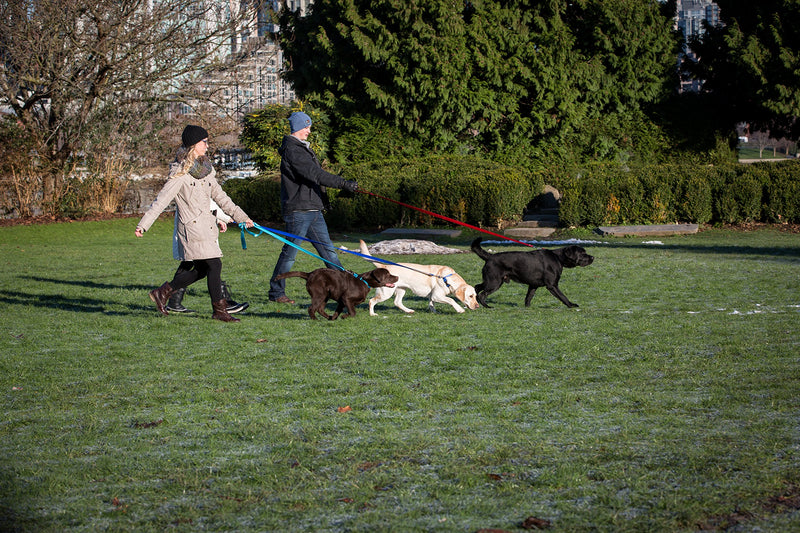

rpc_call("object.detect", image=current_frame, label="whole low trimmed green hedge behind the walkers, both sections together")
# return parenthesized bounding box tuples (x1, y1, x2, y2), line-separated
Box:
(223, 156, 800, 228)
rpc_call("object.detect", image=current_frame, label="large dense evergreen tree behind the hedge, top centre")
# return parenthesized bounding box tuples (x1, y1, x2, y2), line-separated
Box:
(281, 0, 678, 162)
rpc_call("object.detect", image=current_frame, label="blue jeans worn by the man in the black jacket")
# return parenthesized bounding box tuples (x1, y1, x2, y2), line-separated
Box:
(269, 211, 342, 300)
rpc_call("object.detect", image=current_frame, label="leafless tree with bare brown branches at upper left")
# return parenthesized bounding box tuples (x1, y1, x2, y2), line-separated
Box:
(0, 0, 272, 212)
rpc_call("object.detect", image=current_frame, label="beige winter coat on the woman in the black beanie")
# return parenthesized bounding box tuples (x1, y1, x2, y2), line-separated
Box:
(139, 165, 250, 261)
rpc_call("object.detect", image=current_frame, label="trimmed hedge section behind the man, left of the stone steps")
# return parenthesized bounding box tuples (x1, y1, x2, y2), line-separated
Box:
(223, 156, 544, 227)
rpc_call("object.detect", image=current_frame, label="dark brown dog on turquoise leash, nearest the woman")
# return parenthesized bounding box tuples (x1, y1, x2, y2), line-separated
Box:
(275, 268, 398, 320)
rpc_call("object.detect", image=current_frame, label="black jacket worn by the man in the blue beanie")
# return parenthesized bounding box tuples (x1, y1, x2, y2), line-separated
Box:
(278, 135, 345, 216)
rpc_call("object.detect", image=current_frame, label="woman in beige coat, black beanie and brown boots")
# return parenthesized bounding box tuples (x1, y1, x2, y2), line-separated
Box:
(134, 125, 253, 322)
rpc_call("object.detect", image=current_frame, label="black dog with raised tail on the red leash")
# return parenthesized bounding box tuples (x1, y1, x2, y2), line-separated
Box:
(471, 237, 594, 307)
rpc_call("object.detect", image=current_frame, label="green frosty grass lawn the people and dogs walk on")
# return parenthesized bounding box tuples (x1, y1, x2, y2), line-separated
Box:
(0, 219, 800, 532)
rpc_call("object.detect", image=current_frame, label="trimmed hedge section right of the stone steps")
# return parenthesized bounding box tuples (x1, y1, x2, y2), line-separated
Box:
(547, 161, 800, 226)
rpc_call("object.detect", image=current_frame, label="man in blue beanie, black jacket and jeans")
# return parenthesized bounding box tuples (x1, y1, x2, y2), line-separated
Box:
(269, 111, 358, 304)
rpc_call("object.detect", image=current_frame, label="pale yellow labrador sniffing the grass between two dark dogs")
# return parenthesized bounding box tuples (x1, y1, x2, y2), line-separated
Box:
(359, 241, 480, 316)
